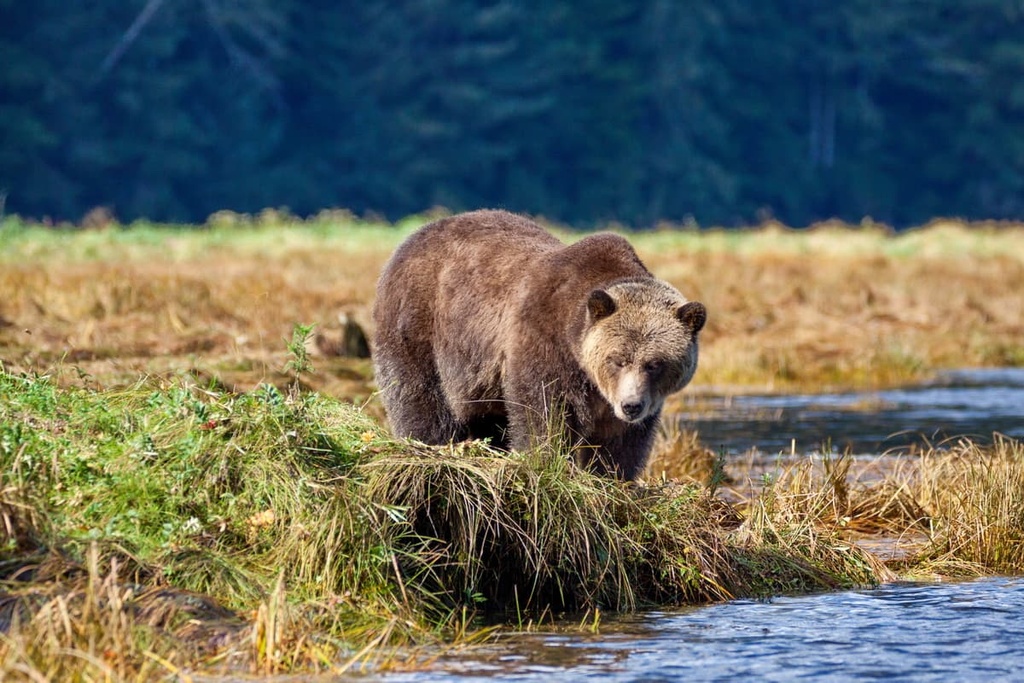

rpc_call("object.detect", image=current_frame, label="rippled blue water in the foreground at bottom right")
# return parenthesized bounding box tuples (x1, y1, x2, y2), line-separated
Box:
(385, 579, 1024, 681)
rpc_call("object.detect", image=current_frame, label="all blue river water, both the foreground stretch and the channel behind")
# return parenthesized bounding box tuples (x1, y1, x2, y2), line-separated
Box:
(374, 369, 1024, 683)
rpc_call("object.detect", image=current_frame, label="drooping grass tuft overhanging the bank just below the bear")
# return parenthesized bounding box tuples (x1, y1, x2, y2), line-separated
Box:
(364, 443, 729, 616)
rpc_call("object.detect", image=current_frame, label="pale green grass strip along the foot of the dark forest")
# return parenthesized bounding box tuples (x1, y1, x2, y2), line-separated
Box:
(6, 210, 1022, 261)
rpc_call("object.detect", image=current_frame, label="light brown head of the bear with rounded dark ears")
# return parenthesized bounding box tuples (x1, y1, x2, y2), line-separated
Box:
(580, 279, 708, 423)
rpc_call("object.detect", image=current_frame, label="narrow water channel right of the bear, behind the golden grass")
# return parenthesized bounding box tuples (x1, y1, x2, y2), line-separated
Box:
(680, 368, 1024, 455)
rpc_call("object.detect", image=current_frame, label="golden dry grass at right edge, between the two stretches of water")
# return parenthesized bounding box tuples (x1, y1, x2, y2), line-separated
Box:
(724, 434, 1024, 577)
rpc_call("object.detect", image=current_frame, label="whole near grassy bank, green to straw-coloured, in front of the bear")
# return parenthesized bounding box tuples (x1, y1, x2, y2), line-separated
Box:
(0, 362, 1024, 680)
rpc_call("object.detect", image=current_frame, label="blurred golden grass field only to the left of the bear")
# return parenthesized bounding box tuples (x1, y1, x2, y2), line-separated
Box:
(0, 214, 399, 411)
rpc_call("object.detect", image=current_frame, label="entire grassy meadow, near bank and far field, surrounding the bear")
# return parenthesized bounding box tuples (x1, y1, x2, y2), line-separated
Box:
(0, 212, 1024, 680)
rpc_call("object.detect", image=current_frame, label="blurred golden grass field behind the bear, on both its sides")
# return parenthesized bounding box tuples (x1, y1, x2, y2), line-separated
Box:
(0, 214, 1024, 400)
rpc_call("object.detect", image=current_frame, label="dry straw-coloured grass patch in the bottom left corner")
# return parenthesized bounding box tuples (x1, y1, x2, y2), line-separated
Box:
(0, 547, 247, 681)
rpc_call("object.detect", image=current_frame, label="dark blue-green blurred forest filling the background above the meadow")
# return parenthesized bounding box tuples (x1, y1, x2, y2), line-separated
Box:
(0, 0, 1024, 226)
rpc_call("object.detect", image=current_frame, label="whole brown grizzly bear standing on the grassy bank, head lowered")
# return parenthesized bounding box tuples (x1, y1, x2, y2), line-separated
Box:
(373, 211, 707, 480)
